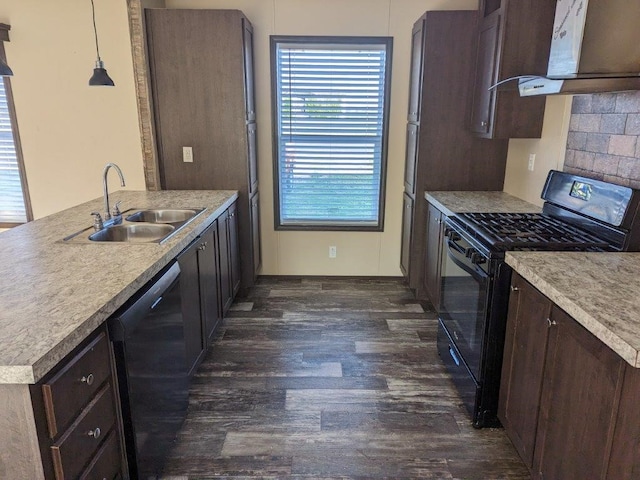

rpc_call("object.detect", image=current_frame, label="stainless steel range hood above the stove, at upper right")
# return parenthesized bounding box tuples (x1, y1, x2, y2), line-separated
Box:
(512, 0, 640, 96)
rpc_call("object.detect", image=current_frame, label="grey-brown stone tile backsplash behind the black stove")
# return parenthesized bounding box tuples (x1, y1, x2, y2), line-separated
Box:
(564, 92, 640, 188)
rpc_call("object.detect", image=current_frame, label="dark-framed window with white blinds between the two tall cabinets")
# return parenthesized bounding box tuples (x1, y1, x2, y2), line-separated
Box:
(271, 37, 392, 231)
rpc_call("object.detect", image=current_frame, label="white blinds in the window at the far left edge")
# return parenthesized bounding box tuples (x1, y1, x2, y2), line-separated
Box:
(0, 78, 27, 223)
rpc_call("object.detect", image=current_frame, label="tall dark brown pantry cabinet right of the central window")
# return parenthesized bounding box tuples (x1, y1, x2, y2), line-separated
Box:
(400, 11, 508, 300)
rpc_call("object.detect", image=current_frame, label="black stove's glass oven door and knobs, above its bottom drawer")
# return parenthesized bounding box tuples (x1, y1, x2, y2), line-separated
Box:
(439, 228, 491, 382)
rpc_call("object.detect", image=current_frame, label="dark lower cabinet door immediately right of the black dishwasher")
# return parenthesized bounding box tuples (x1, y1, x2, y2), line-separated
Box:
(177, 241, 204, 374)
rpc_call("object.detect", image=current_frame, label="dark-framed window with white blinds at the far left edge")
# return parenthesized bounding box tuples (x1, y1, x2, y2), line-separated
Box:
(0, 24, 31, 228)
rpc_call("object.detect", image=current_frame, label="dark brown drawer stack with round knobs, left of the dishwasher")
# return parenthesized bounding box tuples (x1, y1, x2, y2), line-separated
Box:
(30, 327, 126, 480)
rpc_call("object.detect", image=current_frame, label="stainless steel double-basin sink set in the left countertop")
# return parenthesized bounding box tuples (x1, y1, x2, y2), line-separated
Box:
(63, 208, 205, 243)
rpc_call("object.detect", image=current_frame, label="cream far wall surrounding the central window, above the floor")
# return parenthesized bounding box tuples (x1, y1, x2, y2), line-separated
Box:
(166, 0, 478, 275)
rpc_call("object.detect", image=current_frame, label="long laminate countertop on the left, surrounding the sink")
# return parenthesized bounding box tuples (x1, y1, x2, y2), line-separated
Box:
(0, 190, 238, 384)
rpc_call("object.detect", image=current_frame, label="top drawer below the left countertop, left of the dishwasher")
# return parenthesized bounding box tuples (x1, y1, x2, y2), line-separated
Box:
(42, 332, 111, 438)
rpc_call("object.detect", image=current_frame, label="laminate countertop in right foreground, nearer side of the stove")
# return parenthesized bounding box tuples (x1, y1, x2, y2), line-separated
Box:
(506, 252, 640, 368)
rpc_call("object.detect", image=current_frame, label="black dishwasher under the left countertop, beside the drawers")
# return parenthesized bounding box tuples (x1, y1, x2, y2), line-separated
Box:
(109, 263, 189, 480)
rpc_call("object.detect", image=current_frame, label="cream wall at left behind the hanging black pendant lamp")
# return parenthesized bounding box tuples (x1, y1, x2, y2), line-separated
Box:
(0, 0, 145, 221)
